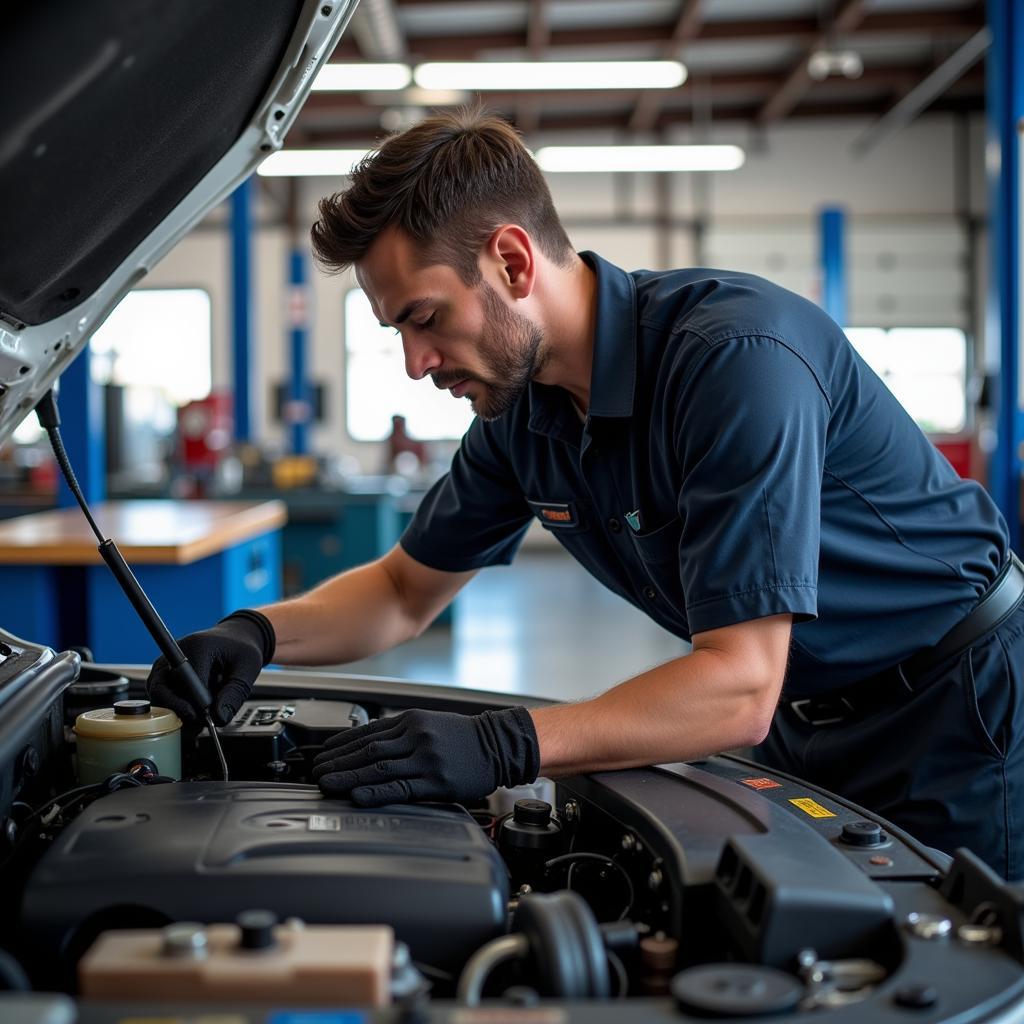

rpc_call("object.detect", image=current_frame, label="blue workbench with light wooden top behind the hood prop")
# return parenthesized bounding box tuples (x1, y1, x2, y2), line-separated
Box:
(0, 501, 287, 663)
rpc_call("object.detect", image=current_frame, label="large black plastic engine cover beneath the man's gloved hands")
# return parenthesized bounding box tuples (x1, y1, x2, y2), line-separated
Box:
(22, 782, 508, 971)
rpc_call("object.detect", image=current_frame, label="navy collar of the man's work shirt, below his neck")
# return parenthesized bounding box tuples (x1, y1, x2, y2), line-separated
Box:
(528, 252, 637, 435)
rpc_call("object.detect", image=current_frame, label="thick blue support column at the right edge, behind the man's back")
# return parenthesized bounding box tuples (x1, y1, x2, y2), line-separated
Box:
(985, 0, 1024, 551)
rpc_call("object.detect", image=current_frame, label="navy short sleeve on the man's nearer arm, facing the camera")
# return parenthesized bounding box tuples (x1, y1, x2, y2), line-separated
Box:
(675, 337, 829, 634)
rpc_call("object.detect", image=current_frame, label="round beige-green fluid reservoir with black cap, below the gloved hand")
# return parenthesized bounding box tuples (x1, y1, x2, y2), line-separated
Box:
(75, 700, 181, 784)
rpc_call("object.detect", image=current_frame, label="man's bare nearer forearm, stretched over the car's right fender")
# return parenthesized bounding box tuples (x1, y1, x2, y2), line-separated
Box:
(530, 650, 777, 775)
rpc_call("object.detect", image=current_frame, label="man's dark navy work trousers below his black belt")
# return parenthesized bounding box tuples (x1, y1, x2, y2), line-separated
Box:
(755, 606, 1024, 881)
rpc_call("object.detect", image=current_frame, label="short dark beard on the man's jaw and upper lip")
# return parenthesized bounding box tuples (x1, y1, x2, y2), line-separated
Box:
(431, 282, 544, 420)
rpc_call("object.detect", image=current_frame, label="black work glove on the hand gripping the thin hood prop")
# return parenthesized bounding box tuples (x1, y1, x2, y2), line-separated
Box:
(145, 608, 278, 725)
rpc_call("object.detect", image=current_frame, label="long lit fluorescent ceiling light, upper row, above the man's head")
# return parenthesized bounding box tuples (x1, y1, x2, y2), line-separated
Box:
(413, 60, 686, 91)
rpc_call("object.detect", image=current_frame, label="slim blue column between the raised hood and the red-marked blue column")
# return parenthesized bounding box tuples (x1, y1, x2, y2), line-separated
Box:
(231, 178, 256, 441)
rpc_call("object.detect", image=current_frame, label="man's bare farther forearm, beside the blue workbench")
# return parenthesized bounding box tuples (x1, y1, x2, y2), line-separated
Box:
(259, 561, 421, 665)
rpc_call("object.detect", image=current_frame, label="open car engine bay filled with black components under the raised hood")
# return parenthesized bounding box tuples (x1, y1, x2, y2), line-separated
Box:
(0, 637, 1024, 1022)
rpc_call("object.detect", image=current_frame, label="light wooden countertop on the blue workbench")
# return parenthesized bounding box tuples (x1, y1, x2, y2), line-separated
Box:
(0, 501, 288, 565)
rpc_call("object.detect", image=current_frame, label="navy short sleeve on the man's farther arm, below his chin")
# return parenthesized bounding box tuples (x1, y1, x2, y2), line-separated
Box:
(399, 419, 532, 572)
